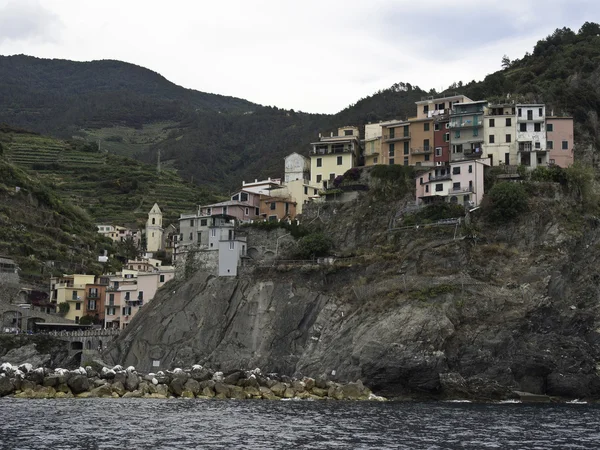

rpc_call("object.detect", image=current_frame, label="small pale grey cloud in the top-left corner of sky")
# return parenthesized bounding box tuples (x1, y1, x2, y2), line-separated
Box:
(0, 0, 62, 42)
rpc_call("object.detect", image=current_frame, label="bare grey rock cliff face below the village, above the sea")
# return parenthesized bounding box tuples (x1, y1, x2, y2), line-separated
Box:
(106, 186, 600, 398)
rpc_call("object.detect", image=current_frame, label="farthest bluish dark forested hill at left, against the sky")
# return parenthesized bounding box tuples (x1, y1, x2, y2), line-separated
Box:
(0, 55, 256, 137)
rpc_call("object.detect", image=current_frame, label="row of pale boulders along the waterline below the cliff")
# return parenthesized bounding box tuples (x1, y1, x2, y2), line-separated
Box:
(0, 363, 385, 401)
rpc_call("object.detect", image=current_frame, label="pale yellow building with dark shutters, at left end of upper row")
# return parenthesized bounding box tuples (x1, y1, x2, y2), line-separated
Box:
(310, 127, 362, 189)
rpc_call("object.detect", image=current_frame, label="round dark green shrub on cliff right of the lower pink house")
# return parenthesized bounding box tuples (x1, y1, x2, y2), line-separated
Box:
(483, 182, 528, 223)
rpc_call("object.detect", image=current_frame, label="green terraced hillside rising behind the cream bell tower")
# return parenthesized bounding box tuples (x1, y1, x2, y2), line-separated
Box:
(0, 127, 218, 225)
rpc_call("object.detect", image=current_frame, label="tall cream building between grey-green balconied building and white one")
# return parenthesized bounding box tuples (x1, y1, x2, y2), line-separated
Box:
(483, 104, 517, 166)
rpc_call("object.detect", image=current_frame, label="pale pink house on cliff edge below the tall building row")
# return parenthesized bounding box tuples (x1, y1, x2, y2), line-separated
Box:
(416, 158, 490, 206)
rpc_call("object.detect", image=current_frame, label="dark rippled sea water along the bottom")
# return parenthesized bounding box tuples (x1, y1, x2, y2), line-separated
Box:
(0, 398, 600, 450)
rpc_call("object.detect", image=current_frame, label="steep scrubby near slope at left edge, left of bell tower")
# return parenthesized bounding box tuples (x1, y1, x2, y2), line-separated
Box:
(0, 148, 112, 282)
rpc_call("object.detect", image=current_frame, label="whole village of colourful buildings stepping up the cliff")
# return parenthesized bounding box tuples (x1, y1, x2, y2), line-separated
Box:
(3, 95, 574, 331)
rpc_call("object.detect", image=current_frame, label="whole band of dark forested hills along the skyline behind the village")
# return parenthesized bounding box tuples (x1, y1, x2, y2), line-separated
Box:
(0, 23, 600, 191)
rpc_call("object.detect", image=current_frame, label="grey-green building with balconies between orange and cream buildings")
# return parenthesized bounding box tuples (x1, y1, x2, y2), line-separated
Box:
(450, 100, 487, 162)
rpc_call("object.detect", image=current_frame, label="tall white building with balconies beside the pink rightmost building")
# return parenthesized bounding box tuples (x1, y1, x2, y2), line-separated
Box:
(516, 104, 550, 169)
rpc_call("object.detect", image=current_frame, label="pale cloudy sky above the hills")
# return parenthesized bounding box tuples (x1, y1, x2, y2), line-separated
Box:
(0, 0, 600, 113)
